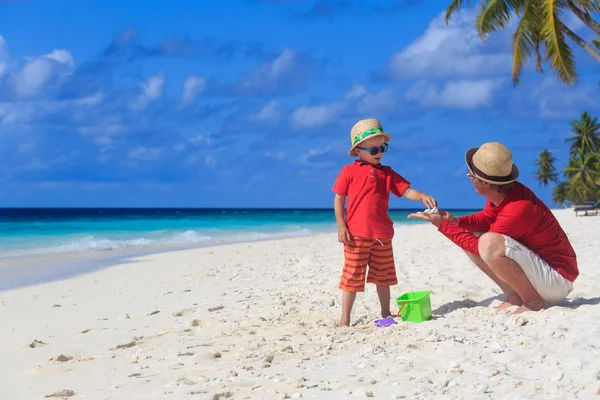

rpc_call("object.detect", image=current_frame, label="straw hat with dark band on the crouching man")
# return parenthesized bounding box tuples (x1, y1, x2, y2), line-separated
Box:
(465, 142, 519, 185)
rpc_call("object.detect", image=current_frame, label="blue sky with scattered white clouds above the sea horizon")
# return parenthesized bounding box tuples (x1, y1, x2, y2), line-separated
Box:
(0, 0, 600, 208)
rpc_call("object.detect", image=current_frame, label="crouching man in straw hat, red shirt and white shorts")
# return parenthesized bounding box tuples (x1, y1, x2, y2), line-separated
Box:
(409, 142, 579, 314)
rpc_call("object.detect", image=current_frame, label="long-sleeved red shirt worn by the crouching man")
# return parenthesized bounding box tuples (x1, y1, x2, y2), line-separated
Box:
(439, 182, 579, 282)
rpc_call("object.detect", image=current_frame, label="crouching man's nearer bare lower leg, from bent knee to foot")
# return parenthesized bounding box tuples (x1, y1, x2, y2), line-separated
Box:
(479, 233, 546, 314)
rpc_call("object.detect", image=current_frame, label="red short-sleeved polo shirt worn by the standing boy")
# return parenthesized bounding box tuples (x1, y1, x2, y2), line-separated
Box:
(332, 160, 410, 239)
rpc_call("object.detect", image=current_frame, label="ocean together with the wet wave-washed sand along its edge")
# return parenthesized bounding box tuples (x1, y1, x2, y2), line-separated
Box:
(0, 208, 473, 290)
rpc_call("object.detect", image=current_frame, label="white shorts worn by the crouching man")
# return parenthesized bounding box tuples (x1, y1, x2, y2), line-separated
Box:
(503, 235, 573, 305)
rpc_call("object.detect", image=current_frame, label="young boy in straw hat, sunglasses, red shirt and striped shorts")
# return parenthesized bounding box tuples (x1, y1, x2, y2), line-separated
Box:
(332, 119, 437, 326)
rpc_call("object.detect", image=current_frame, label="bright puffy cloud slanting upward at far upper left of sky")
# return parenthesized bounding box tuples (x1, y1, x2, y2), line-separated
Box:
(13, 50, 75, 98)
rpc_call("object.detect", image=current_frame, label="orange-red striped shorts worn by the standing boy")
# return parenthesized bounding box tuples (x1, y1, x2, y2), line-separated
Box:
(339, 237, 398, 292)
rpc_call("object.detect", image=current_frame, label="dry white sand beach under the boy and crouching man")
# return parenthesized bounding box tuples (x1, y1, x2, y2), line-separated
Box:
(0, 210, 600, 400)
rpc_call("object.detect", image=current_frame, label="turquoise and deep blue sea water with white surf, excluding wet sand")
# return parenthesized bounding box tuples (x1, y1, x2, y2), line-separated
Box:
(0, 208, 472, 258)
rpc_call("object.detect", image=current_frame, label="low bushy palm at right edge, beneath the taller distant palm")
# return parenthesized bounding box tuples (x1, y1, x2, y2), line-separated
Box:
(565, 153, 600, 203)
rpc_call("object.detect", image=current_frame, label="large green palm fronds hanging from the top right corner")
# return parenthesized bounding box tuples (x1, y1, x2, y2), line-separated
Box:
(446, 0, 600, 86)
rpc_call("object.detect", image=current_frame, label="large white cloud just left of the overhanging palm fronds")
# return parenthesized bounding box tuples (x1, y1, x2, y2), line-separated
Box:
(387, 11, 512, 79)
